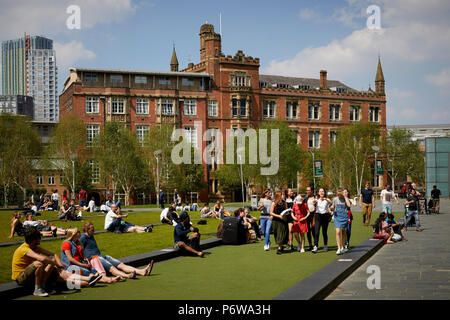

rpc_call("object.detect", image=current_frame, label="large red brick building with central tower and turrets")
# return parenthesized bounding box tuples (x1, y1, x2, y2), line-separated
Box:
(59, 24, 386, 202)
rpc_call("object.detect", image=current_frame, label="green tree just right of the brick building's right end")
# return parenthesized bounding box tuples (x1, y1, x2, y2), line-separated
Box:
(383, 127, 425, 188)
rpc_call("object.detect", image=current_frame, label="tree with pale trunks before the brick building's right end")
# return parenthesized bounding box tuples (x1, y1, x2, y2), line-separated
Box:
(327, 123, 380, 194)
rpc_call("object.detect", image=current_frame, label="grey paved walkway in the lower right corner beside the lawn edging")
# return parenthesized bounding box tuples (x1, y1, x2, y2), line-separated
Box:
(326, 199, 450, 300)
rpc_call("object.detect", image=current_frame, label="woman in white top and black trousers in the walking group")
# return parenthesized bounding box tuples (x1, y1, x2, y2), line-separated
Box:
(312, 188, 332, 253)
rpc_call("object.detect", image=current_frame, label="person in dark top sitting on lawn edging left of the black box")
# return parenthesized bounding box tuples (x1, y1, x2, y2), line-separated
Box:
(173, 211, 203, 257)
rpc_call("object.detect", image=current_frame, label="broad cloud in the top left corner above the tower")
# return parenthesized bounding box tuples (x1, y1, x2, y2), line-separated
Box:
(0, 0, 136, 40)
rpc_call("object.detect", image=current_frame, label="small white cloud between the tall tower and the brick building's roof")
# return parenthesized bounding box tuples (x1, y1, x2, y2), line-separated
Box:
(53, 41, 96, 72)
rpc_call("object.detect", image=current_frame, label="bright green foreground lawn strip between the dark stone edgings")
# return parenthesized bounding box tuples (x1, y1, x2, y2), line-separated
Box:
(22, 213, 386, 300)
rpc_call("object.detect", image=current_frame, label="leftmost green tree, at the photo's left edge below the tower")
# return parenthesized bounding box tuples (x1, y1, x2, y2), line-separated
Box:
(0, 113, 41, 208)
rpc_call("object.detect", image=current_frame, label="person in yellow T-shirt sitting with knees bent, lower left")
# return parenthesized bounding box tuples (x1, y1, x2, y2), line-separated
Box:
(11, 229, 100, 297)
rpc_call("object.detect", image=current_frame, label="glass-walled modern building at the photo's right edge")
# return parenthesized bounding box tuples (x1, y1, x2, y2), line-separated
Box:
(425, 137, 450, 197)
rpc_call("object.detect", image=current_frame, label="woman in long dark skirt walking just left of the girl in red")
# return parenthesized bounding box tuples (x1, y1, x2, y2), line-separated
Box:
(270, 191, 289, 254)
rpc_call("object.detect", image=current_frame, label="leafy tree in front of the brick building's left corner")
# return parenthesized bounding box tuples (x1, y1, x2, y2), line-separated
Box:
(42, 115, 90, 197)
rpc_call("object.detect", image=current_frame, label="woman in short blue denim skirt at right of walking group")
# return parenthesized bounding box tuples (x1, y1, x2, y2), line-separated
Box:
(331, 188, 351, 255)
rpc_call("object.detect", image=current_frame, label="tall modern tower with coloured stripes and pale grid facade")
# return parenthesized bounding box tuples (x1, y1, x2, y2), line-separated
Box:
(2, 35, 59, 122)
